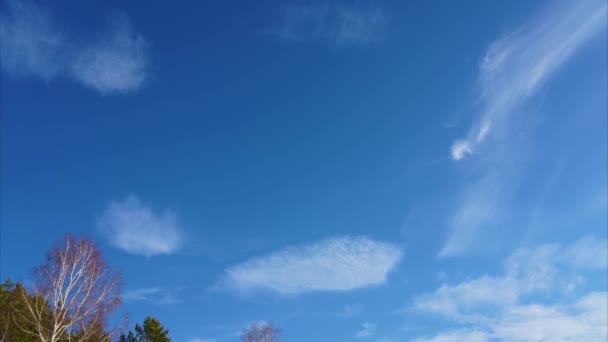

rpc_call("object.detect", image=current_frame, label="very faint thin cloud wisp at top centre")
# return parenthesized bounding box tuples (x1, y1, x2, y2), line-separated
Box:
(270, 4, 388, 47)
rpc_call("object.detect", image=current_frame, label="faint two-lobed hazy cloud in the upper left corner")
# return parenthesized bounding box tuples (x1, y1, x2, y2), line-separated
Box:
(0, 0, 147, 94)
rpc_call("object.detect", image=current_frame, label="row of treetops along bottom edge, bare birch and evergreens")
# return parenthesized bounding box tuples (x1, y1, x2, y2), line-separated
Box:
(0, 235, 280, 342)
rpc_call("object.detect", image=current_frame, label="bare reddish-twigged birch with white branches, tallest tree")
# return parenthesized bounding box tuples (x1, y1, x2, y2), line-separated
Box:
(19, 235, 121, 342)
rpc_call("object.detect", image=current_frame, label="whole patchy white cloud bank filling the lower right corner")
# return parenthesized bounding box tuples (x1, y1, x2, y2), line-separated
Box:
(414, 236, 608, 342)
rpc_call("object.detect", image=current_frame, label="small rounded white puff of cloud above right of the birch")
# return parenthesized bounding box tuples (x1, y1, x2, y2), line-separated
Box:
(98, 195, 183, 257)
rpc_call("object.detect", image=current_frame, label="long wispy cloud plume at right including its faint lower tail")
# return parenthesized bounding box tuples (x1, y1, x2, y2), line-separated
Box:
(439, 0, 607, 257)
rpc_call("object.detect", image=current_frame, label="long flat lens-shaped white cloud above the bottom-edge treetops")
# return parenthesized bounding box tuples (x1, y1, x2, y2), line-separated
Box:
(219, 237, 402, 294)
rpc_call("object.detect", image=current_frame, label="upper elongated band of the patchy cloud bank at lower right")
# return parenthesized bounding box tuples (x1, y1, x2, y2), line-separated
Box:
(426, 236, 608, 318)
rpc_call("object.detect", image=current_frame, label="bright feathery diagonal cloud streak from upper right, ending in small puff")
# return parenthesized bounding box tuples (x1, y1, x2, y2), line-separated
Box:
(452, 0, 607, 160)
